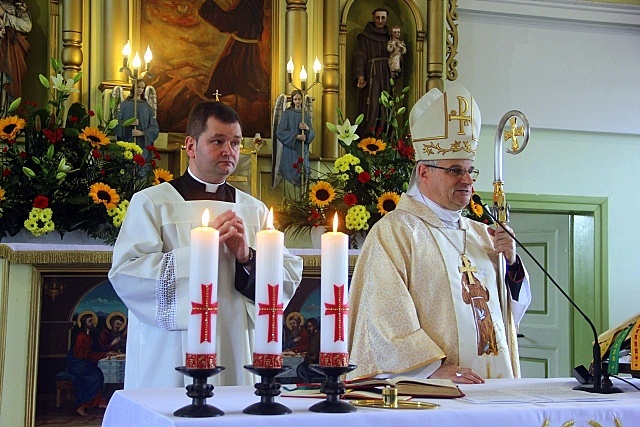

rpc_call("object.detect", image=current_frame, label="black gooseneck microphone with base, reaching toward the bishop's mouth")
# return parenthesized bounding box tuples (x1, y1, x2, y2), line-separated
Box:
(471, 194, 622, 394)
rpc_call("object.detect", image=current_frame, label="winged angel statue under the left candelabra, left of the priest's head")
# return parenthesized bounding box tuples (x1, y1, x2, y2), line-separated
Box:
(116, 80, 160, 149)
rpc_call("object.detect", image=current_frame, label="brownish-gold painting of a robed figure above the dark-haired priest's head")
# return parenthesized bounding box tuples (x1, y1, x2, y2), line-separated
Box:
(139, 0, 273, 138)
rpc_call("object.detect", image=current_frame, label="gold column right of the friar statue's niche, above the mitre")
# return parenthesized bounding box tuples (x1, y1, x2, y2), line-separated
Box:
(427, 0, 444, 91)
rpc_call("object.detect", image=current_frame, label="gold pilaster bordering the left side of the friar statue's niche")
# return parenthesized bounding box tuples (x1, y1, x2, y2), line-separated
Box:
(320, 0, 340, 159)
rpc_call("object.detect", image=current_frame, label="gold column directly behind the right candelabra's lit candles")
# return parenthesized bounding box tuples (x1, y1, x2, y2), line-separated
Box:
(284, 0, 313, 92)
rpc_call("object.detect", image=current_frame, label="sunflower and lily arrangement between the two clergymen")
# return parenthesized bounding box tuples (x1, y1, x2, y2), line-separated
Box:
(277, 79, 415, 241)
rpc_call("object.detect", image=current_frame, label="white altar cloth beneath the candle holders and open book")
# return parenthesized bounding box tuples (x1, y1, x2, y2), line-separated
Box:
(102, 378, 640, 427)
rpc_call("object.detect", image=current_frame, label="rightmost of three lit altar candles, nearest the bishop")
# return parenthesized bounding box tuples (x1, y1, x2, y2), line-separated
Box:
(320, 213, 349, 366)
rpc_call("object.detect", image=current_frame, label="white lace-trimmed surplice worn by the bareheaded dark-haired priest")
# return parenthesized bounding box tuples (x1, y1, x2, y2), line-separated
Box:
(109, 183, 302, 388)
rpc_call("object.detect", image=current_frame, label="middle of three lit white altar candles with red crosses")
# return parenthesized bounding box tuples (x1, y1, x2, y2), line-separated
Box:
(253, 208, 284, 368)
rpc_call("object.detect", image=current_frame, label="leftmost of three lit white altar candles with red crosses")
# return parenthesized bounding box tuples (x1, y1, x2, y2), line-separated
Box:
(185, 209, 220, 369)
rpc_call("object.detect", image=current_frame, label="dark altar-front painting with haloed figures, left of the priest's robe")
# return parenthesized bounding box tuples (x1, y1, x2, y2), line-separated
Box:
(36, 271, 128, 423)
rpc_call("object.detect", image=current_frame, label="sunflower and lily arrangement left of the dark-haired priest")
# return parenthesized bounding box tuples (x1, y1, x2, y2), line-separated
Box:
(0, 58, 172, 244)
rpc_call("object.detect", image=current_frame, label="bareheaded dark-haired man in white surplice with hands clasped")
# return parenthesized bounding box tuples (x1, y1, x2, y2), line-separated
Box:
(109, 101, 302, 388)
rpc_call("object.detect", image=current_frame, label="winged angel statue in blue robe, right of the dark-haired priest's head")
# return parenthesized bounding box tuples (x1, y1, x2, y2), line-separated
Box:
(271, 90, 316, 188)
